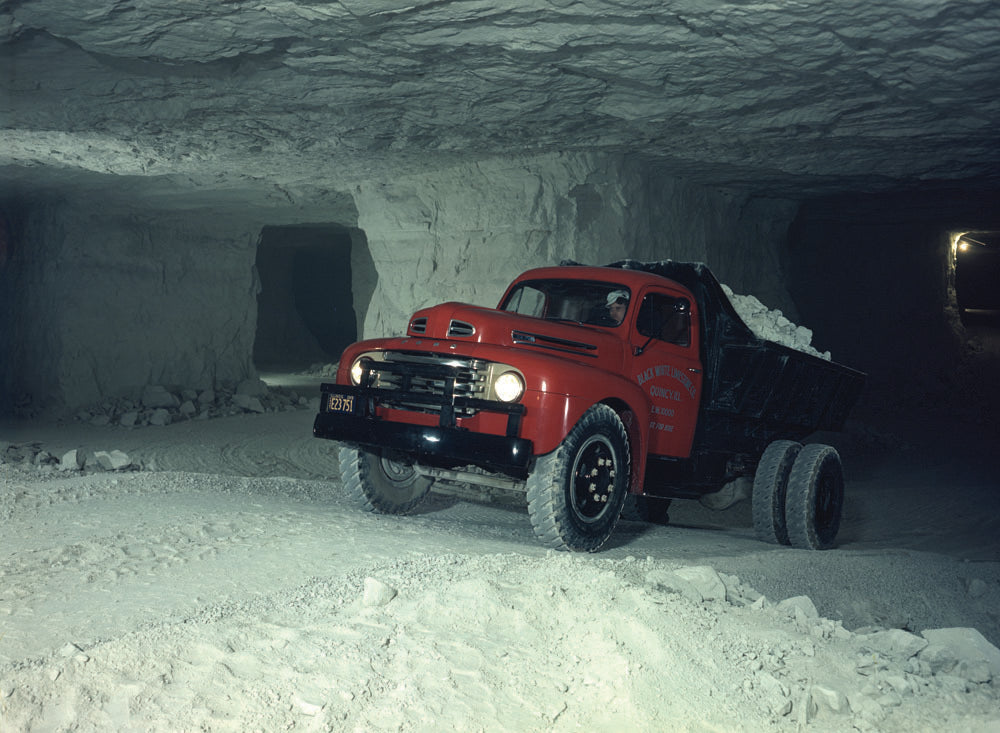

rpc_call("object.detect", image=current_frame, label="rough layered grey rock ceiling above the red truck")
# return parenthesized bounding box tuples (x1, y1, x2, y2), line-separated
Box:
(0, 0, 1000, 212)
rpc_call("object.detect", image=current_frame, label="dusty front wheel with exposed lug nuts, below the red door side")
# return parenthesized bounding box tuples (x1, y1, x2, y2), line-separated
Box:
(527, 404, 630, 552)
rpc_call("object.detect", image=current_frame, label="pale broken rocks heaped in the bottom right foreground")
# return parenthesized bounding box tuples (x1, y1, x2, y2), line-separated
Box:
(645, 566, 1000, 731)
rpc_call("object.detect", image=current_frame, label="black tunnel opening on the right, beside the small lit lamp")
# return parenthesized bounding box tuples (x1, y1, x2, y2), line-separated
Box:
(787, 190, 1000, 423)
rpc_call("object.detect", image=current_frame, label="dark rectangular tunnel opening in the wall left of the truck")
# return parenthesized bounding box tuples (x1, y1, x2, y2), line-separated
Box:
(253, 224, 358, 372)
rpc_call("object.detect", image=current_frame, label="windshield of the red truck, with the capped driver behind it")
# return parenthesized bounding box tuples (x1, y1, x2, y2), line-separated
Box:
(500, 280, 631, 326)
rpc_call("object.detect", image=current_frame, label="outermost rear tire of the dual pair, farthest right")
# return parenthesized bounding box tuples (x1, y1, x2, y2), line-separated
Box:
(785, 443, 844, 550)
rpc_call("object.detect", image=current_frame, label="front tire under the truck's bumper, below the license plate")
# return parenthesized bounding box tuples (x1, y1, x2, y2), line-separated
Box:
(340, 446, 434, 514)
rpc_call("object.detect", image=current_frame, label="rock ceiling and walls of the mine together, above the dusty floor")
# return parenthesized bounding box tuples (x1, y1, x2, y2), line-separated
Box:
(0, 3, 1000, 426)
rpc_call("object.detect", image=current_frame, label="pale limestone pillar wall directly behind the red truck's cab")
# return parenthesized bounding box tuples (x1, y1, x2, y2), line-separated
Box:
(356, 154, 795, 338)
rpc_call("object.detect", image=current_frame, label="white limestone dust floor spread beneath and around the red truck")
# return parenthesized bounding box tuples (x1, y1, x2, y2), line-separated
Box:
(0, 400, 1000, 733)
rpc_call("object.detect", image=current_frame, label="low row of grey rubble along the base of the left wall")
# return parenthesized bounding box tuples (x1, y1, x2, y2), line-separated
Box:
(76, 379, 309, 428)
